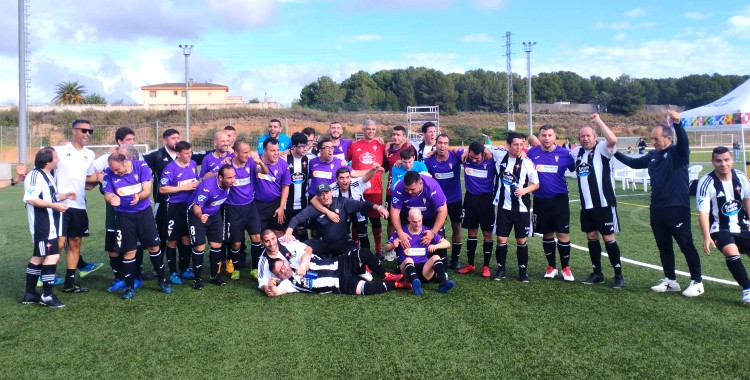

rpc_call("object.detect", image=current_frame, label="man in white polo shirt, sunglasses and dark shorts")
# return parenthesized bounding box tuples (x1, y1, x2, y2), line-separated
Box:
(54, 119, 104, 293)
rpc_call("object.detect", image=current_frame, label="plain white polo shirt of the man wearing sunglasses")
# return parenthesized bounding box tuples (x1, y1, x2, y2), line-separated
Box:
(55, 143, 96, 210)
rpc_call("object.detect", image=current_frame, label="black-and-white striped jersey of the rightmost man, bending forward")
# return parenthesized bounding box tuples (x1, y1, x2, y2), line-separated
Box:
(695, 169, 750, 233)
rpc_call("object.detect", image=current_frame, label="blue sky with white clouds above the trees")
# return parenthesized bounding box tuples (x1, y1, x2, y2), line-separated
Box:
(0, 0, 750, 105)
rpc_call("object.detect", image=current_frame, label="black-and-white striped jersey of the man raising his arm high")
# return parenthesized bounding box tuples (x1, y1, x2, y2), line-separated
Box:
(570, 141, 617, 210)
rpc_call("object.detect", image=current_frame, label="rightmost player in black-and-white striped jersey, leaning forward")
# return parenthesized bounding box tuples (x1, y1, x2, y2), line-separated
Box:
(700, 147, 750, 305)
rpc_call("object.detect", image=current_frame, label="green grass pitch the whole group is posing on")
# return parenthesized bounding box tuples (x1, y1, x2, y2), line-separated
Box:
(0, 179, 750, 379)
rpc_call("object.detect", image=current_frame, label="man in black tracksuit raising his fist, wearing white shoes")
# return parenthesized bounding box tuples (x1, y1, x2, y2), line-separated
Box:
(615, 110, 703, 297)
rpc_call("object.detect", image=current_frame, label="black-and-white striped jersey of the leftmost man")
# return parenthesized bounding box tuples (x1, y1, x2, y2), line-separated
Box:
(23, 169, 60, 242)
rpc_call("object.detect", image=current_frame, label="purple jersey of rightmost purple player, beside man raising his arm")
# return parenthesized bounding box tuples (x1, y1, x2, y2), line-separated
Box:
(526, 145, 575, 198)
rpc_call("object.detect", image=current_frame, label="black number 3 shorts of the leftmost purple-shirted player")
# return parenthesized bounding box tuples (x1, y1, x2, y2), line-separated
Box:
(115, 208, 161, 252)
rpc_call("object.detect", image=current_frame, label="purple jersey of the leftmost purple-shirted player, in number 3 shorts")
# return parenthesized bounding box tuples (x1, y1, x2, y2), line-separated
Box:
(102, 160, 153, 213)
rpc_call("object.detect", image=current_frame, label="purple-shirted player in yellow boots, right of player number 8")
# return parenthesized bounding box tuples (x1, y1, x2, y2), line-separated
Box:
(225, 141, 268, 285)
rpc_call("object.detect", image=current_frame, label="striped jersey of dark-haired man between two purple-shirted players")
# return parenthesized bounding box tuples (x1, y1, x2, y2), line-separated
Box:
(490, 149, 539, 212)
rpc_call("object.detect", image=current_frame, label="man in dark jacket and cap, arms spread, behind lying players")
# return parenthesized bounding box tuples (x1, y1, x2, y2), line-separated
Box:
(284, 183, 388, 256)
